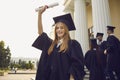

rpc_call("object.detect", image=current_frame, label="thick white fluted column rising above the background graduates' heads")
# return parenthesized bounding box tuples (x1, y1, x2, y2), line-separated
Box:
(92, 0, 111, 39)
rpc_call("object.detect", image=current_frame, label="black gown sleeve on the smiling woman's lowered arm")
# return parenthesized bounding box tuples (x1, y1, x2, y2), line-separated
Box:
(70, 40, 85, 80)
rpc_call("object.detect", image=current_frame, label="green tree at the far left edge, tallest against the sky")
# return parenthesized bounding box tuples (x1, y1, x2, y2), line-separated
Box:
(0, 41, 11, 69)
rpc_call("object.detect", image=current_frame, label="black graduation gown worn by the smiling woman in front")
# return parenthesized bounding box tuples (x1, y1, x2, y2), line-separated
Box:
(32, 33, 85, 80)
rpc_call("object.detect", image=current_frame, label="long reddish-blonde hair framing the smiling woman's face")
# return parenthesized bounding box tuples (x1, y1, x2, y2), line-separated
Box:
(48, 22, 70, 55)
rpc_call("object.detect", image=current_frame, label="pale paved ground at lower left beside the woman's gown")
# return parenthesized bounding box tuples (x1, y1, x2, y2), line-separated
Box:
(0, 70, 89, 80)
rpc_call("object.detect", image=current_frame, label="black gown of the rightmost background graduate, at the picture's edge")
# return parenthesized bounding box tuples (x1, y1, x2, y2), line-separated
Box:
(107, 35, 120, 80)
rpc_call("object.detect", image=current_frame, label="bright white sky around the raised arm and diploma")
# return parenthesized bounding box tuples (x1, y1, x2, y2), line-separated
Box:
(0, 0, 64, 58)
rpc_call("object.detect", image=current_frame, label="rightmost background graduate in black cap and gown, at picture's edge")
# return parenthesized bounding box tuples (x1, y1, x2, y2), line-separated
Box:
(104, 26, 120, 80)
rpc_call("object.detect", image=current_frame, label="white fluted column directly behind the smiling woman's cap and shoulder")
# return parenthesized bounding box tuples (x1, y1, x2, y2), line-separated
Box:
(74, 0, 89, 54)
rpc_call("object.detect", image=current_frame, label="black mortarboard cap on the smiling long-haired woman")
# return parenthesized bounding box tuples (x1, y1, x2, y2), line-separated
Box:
(53, 13, 76, 31)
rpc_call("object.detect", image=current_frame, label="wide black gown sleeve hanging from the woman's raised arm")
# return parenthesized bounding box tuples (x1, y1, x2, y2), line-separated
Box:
(32, 32, 52, 51)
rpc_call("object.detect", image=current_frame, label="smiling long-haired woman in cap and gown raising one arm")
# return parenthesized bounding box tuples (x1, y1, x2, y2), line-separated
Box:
(32, 6, 85, 80)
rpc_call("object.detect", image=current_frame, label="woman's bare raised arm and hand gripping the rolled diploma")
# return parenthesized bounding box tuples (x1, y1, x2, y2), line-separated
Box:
(38, 5, 48, 35)
